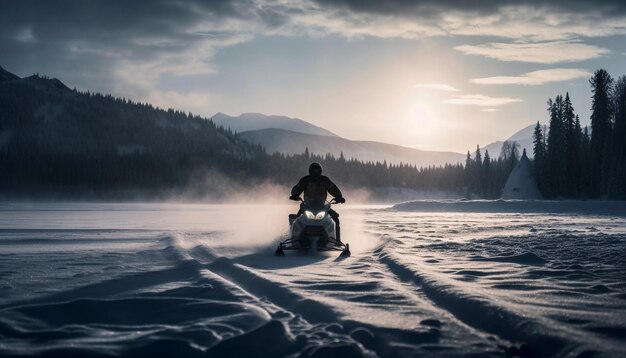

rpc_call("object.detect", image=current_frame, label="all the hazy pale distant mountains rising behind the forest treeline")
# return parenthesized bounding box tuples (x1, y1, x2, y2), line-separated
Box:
(212, 113, 534, 167)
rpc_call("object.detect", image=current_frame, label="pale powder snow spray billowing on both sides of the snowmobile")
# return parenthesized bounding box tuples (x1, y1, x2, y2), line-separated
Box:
(168, 170, 377, 250)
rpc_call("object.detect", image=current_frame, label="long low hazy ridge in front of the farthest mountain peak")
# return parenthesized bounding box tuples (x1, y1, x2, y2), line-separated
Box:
(240, 128, 465, 167)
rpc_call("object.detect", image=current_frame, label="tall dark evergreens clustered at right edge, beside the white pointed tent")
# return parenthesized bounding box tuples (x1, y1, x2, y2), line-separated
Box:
(533, 69, 626, 199)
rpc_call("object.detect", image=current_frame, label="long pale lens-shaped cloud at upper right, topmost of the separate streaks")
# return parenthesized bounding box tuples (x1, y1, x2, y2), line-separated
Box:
(455, 41, 610, 64)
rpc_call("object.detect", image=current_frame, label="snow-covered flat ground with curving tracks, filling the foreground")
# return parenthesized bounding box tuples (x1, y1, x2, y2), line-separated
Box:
(0, 202, 626, 357)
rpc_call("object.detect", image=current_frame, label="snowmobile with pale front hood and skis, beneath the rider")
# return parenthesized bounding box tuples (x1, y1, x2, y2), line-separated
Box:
(276, 199, 350, 257)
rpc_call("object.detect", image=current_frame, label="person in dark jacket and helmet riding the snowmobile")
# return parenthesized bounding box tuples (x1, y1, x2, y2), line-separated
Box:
(289, 163, 346, 242)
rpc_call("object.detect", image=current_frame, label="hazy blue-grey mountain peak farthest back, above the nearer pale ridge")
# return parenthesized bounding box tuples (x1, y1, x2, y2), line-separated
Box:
(211, 112, 336, 137)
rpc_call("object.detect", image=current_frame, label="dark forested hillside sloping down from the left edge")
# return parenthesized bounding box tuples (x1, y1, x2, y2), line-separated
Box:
(0, 71, 264, 193)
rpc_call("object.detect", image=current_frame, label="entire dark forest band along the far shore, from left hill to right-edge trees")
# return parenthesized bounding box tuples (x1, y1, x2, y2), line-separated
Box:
(0, 68, 626, 199)
